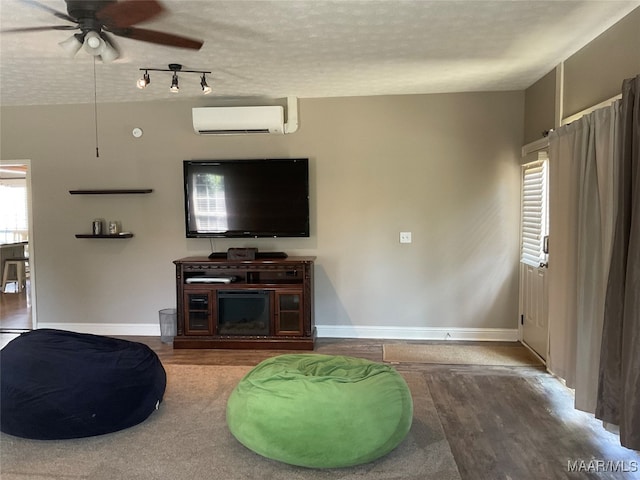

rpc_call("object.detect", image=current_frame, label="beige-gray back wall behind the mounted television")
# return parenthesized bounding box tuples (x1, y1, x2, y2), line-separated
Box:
(0, 92, 524, 336)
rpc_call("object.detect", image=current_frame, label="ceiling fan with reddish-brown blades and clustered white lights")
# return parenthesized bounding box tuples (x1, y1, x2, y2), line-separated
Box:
(2, 0, 203, 62)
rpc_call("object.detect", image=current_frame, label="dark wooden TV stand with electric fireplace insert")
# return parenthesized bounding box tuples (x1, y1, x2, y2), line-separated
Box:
(173, 257, 316, 350)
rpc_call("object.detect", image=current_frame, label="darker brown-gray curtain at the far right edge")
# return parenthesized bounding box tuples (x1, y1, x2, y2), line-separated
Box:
(596, 75, 640, 450)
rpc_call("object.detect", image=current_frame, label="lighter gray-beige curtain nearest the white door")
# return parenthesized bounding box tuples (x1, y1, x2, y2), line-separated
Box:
(547, 101, 620, 413)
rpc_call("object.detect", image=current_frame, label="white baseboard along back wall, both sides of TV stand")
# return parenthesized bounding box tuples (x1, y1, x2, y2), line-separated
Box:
(38, 323, 518, 342)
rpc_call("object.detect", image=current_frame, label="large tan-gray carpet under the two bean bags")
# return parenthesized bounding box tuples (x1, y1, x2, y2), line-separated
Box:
(0, 365, 460, 480)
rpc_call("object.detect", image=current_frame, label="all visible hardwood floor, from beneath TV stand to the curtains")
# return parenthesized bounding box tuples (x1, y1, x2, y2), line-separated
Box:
(0, 334, 640, 480)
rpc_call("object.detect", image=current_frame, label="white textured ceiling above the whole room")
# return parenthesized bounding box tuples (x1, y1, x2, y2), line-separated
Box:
(0, 0, 640, 105)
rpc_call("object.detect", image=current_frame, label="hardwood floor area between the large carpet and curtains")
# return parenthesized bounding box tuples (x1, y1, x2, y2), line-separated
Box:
(425, 369, 640, 480)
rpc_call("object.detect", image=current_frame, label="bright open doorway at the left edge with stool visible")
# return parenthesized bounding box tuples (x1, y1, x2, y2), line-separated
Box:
(0, 160, 36, 332)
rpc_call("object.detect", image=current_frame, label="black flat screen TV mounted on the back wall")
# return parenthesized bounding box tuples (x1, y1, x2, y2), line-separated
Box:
(184, 158, 309, 238)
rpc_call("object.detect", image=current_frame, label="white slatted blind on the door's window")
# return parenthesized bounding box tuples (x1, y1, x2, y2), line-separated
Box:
(520, 157, 548, 267)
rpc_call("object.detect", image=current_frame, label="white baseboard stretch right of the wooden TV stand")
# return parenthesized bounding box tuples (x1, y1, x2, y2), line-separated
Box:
(316, 325, 518, 342)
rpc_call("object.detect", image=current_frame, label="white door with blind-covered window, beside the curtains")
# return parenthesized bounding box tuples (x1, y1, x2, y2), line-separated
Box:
(520, 158, 549, 359)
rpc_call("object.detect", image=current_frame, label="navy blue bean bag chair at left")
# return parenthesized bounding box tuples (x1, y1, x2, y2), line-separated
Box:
(0, 329, 167, 440)
